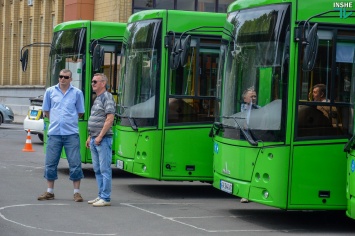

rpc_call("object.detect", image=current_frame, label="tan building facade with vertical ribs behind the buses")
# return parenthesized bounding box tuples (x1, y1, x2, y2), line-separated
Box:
(0, 0, 233, 122)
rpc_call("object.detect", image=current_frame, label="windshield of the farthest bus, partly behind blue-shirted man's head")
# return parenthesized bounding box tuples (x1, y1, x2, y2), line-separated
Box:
(46, 28, 86, 90)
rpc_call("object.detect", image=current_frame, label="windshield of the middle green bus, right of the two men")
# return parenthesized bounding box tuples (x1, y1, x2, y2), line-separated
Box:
(119, 20, 161, 121)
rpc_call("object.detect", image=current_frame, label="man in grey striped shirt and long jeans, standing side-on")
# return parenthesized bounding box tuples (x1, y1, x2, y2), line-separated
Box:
(86, 74, 115, 207)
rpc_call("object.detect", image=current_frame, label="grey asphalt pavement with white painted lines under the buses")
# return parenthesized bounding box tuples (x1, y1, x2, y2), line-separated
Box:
(0, 123, 355, 236)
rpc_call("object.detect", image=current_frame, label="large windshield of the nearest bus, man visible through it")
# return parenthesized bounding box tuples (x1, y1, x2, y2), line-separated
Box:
(218, 5, 290, 143)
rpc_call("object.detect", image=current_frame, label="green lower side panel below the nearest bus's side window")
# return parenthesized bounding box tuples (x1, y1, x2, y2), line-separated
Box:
(290, 144, 346, 209)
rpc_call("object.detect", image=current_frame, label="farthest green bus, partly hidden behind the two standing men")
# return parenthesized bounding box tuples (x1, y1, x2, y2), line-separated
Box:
(21, 20, 126, 163)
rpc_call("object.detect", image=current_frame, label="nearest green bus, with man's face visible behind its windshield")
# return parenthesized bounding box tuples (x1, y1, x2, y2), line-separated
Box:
(211, 0, 355, 217)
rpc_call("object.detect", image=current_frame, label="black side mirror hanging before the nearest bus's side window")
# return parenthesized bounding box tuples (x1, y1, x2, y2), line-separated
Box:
(302, 23, 319, 71)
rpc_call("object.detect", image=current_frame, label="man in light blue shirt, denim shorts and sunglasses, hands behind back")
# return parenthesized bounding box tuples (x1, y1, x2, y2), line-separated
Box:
(38, 69, 85, 202)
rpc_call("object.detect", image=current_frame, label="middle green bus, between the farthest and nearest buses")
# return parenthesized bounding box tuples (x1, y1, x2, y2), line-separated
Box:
(114, 10, 226, 182)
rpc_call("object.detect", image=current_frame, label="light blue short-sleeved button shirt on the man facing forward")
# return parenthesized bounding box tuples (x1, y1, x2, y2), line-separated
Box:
(42, 84, 85, 135)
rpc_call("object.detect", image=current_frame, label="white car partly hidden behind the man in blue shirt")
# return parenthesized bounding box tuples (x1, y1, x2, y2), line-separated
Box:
(23, 96, 44, 142)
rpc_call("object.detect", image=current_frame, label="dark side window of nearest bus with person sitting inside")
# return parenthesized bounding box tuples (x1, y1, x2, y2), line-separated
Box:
(297, 30, 355, 137)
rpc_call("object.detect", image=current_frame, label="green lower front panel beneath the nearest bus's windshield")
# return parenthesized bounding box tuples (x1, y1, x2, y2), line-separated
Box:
(213, 141, 290, 209)
